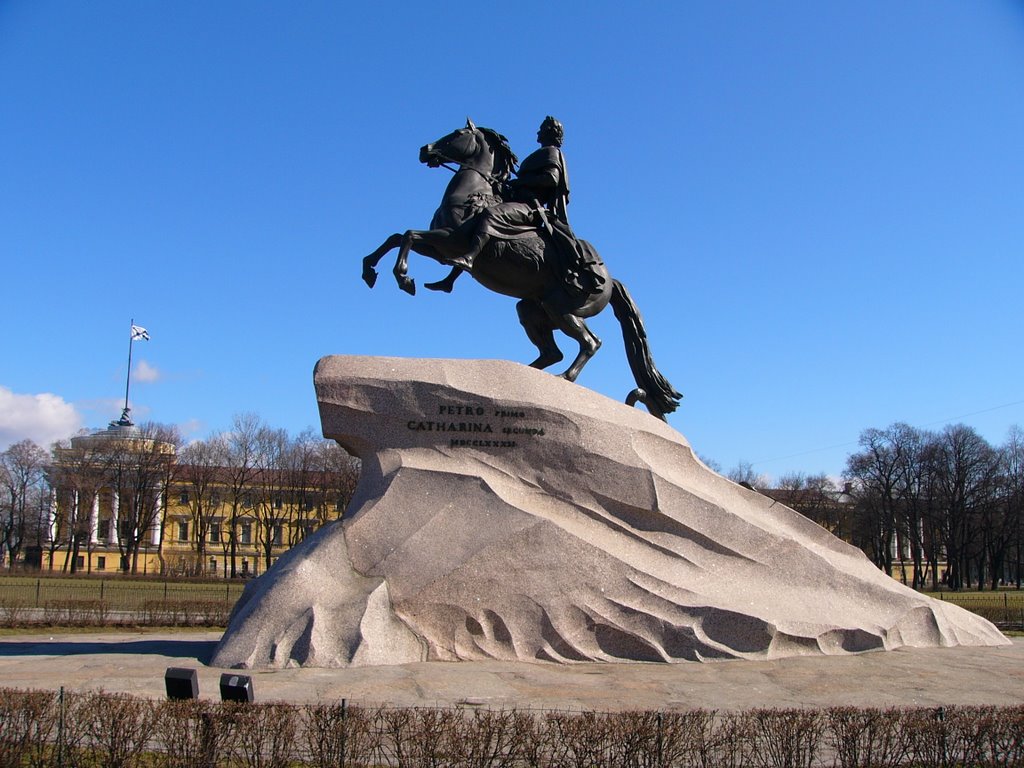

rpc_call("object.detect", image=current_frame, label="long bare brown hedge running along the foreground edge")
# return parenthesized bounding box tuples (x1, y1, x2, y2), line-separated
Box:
(0, 688, 1024, 768)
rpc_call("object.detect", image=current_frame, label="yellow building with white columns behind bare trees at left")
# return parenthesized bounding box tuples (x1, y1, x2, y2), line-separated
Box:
(41, 419, 355, 578)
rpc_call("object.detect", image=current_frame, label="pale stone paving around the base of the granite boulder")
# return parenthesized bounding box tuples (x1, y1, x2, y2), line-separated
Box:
(0, 631, 1024, 711)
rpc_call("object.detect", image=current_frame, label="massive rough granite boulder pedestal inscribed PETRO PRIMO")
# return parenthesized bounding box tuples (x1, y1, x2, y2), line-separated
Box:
(213, 356, 1008, 668)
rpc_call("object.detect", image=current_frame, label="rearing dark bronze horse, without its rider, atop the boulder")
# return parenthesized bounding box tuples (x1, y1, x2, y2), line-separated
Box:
(362, 121, 682, 420)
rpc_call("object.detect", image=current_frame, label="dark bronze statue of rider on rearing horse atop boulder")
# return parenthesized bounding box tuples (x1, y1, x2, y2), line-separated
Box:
(362, 117, 682, 420)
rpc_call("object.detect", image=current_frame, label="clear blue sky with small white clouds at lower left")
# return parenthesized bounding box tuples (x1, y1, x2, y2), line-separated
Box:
(0, 0, 1024, 476)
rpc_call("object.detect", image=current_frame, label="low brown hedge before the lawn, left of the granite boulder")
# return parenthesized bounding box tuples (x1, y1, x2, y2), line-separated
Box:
(0, 599, 231, 627)
